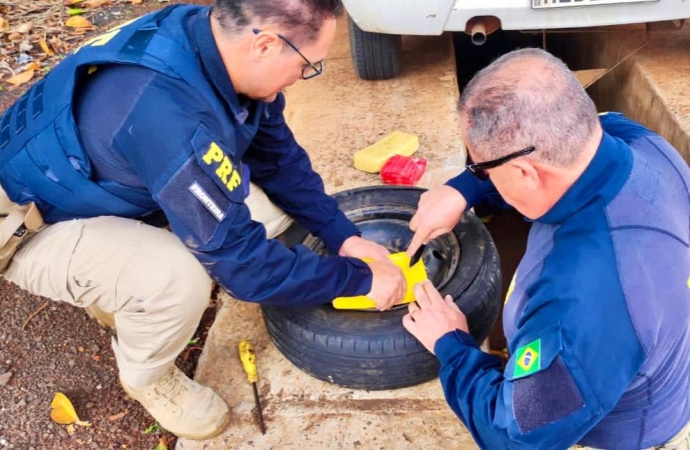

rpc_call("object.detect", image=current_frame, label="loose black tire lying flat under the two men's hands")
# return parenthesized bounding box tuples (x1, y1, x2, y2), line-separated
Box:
(262, 186, 501, 390)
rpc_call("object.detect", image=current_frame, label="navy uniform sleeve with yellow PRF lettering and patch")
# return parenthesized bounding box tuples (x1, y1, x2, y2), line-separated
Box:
(113, 76, 371, 305)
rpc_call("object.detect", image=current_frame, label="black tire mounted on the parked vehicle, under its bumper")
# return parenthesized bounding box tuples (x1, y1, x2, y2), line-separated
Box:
(348, 16, 400, 80)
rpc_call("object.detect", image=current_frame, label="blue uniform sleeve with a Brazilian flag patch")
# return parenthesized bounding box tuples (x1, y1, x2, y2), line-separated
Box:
(434, 286, 644, 450)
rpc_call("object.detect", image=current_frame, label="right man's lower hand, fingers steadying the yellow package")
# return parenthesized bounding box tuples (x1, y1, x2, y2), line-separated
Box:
(403, 280, 468, 354)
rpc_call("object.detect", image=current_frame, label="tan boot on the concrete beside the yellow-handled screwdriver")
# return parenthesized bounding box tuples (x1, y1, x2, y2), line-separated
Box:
(120, 366, 230, 439)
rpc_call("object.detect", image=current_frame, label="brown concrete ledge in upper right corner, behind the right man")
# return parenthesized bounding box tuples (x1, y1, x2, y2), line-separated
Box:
(573, 23, 690, 162)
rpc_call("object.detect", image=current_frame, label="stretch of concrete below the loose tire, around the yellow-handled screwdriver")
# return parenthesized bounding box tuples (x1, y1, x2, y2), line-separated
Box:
(176, 297, 477, 450)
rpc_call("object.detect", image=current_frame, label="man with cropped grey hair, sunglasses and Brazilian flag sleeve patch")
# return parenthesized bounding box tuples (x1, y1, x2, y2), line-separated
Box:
(403, 49, 690, 450)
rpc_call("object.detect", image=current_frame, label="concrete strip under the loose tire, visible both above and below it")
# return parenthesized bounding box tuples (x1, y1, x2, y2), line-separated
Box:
(177, 14, 477, 450)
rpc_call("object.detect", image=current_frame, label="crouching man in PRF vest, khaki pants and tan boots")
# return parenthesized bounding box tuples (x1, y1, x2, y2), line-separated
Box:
(0, 0, 405, 439)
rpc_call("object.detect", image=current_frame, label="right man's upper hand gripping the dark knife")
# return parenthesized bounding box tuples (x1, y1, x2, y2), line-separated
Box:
(407, 185, 467, 256)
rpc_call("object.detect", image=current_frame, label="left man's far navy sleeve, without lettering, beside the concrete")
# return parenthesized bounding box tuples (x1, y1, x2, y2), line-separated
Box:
(243, 94, 361, 254)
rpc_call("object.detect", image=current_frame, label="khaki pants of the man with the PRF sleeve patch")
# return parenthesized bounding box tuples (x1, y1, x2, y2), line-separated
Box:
(0, 185, 292, 388)
